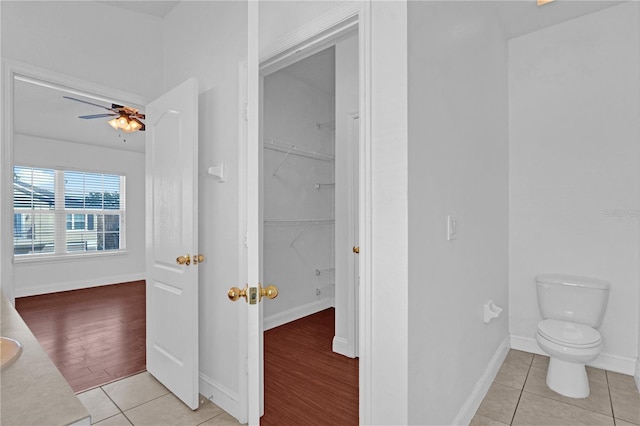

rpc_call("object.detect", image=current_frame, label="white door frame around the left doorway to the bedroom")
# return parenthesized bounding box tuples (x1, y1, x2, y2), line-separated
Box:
(0, 59, 147, 305)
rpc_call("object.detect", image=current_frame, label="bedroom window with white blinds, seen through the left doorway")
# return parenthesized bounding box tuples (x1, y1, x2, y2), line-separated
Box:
(13, 166, 125, 256)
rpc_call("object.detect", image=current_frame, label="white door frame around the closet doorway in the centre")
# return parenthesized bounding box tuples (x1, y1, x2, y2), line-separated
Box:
(246, 1, 373, 424)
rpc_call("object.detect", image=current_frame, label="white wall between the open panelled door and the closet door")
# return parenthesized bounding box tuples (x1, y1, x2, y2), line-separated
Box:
(162, 1, 247, 418)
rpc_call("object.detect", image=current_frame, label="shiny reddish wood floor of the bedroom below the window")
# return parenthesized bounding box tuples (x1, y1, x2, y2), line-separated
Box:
(16, 281, 146, 392)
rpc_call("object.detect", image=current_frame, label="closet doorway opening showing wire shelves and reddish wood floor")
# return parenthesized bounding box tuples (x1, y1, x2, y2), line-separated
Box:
(260, 32, 359, 422)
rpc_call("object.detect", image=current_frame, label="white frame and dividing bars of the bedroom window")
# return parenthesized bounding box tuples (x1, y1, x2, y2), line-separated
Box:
(12, 164, 127, 264)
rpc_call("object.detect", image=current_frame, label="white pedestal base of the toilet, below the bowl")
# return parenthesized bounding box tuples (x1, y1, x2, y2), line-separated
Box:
(547, 357, 589, 398)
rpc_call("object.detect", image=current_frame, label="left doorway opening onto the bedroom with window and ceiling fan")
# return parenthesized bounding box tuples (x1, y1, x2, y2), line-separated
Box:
(2, 63, 145, 391)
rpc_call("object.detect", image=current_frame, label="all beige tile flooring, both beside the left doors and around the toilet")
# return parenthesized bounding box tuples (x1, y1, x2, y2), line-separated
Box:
(78, 350, 640, 426)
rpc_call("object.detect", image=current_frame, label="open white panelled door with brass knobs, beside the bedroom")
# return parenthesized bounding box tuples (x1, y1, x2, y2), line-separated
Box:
(146, 79, 200, 410)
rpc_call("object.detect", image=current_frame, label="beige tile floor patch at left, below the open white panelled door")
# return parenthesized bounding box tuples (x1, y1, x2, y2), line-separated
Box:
(78, 372, 240, 426)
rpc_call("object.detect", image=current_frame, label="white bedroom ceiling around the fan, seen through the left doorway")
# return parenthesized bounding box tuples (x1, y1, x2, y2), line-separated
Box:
(14, 81, 145, 152)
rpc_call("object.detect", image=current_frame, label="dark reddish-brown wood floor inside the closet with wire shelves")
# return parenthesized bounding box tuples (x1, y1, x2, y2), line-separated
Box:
(260, 308, 358, 426)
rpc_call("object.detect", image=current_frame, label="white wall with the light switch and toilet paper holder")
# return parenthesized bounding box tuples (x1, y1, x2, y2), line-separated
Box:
(408, 2, 510, 424)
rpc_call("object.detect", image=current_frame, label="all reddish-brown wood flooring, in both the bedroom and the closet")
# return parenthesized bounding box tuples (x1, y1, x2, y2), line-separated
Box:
(16, 281, 358, 426)
